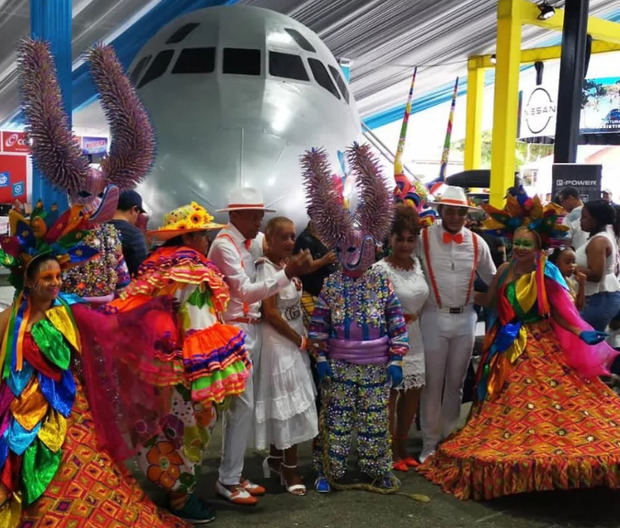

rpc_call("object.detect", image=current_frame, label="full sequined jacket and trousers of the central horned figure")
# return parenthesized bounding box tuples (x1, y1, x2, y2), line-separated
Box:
(309, 268, 409, 480)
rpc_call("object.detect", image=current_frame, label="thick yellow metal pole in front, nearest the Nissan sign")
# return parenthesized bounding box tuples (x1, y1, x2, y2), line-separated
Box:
(490, 0, 521, 207)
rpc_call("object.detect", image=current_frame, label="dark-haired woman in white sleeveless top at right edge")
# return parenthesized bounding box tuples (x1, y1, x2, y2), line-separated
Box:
(577, 200, 620, 332)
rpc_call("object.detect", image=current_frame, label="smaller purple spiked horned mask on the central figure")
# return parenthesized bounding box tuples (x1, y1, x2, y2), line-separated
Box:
(302, 143, 393, 275)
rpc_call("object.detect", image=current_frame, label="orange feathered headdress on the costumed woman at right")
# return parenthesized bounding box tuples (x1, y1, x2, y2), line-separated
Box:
(481, 186, 569, 247)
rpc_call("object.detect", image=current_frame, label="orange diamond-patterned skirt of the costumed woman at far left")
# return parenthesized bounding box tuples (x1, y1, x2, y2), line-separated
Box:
(18, 384, 191, 528)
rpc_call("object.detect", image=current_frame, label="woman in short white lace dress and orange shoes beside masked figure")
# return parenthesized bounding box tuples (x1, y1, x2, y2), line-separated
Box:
(375, 205, 429, 471)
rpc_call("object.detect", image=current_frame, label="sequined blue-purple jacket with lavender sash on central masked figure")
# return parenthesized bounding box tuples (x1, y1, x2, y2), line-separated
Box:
(309, 268, 409, 364)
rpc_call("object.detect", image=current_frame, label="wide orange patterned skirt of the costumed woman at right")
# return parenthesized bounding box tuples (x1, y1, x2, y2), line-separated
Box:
(418, 322, 620, 500)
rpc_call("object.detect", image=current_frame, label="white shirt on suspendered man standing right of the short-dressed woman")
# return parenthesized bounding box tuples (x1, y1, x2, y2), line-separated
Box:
(418, 224, 496, 308)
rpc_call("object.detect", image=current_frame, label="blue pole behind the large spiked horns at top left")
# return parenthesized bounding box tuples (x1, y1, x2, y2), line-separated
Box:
(30, 0, 73, 211)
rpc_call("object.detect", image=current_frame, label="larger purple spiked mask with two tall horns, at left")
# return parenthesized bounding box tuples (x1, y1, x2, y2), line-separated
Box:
(19, 39, 155, 222)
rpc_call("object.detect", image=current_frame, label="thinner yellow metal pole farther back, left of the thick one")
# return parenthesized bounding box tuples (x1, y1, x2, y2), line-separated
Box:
(465, 57, 484, 170)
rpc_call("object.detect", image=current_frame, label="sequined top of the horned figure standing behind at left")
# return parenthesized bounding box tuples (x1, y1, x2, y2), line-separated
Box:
(62, 224, 130, 302)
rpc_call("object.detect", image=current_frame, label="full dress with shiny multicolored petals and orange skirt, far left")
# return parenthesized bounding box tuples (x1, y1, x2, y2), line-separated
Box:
(0, 295, 188, 528)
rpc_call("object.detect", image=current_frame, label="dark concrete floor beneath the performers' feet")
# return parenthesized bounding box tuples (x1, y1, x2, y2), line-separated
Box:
(134, 406, 620, 528)
